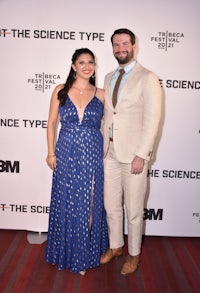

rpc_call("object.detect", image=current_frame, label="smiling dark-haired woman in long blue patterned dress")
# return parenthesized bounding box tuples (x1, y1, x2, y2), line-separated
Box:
(46, 48, 108, 275)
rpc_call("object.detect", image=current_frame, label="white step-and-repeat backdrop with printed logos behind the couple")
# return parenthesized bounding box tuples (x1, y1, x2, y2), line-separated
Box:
(0, 0, 200, 236)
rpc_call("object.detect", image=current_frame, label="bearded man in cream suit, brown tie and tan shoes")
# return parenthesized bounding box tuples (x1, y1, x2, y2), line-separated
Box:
(101, 29, 161, 275)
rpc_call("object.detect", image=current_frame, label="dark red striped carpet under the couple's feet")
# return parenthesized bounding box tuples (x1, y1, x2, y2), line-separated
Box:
(0, 230, 200, 293)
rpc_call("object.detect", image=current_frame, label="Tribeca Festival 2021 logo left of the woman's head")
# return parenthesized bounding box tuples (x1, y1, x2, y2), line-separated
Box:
(27, 72, 61, 93)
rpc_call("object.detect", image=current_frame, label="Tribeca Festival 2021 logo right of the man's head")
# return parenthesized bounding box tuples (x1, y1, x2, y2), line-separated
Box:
(151, 31, 184, 51)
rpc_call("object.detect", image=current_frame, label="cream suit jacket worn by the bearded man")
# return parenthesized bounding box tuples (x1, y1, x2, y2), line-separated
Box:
(102, 63, 162, 163)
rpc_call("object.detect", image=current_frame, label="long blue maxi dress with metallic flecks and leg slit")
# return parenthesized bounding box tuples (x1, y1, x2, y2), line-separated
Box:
(46, 96, 108, 272)
